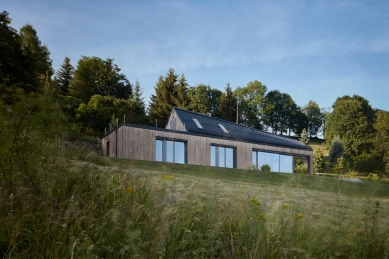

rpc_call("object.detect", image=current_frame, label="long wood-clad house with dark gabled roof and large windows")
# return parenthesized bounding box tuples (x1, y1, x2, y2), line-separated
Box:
(101, 108, 313, 174)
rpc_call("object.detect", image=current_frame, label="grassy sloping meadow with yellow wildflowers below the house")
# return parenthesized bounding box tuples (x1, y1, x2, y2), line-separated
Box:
(0, 145, 389, 258)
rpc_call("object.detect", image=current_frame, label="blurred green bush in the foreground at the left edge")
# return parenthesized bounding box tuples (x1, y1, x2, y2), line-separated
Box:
(0, 91, 60, 191)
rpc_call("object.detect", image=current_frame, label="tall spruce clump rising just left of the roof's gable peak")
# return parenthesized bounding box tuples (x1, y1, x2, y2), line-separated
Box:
(149, 68, 189, 127)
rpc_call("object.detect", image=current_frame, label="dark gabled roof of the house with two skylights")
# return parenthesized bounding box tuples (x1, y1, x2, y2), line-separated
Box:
(173, 108, 312, 150)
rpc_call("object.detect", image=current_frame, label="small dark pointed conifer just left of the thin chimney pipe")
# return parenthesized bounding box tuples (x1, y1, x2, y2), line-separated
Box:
(215, 83, 236, 122)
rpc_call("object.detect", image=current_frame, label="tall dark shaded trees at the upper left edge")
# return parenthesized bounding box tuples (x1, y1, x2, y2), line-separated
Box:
(0, 11, 51, 104)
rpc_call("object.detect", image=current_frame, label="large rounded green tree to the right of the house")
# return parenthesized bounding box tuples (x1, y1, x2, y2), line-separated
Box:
(325, 95, 374, 161)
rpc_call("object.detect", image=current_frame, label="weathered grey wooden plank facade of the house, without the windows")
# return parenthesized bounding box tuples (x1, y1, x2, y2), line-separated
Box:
(101, 124, 313, 174)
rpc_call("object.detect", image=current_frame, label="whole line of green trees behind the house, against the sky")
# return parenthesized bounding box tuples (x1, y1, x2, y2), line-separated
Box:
(0, 11, 389, 177)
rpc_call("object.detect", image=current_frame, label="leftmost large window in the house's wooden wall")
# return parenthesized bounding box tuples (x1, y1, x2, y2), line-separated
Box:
(155, 139, 186, 164)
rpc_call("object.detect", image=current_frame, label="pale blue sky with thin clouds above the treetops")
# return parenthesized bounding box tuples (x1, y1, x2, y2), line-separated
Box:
(0, 0, 389, 110)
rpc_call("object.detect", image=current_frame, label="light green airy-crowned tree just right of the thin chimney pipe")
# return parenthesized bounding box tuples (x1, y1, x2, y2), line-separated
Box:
(234, 80, 267, 130)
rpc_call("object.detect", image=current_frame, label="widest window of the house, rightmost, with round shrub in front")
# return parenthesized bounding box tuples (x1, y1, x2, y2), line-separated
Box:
(252, 150, 293, 173)
